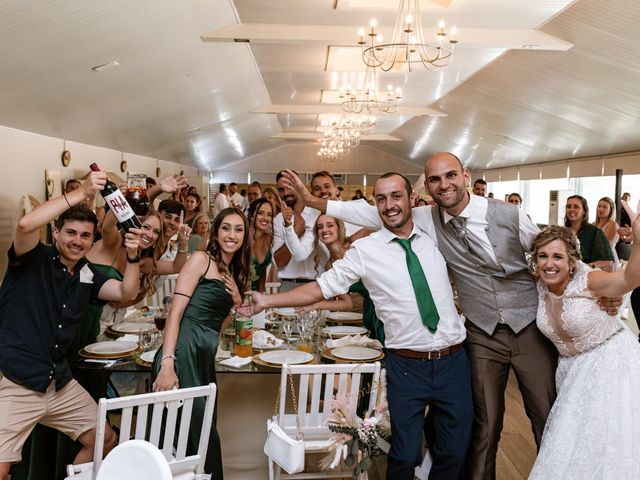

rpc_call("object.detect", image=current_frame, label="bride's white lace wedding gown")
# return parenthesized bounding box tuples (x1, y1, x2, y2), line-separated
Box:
(529, 264, 640, 480)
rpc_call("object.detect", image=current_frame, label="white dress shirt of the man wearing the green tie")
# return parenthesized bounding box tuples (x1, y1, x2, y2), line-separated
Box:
(317, 226, 466, 352)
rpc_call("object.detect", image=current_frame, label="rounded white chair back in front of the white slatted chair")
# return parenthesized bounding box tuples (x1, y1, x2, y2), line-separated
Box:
(96, 440, 173, 480)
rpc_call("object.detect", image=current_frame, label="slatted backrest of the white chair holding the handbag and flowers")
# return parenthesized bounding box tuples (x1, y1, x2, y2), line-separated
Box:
(278, 362, 380, 436)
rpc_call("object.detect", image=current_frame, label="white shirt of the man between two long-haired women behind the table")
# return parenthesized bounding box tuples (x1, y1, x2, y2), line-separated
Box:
(271, 207, 324, 280)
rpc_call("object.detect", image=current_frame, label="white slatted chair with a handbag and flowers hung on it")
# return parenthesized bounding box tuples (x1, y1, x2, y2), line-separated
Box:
(269, 362, 380, 480)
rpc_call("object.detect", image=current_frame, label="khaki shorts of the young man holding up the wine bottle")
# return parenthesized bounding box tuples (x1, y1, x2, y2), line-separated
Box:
(0, 372, 98, 463)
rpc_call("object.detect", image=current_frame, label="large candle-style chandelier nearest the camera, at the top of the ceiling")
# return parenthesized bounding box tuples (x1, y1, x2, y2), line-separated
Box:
(358, 0, 458, 72)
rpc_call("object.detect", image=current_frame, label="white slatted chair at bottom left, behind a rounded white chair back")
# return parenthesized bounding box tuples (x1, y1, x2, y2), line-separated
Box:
(66, 383, 216, 480)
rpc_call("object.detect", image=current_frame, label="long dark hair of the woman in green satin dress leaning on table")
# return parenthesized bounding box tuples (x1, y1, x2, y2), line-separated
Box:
(207, 207, 251, 292)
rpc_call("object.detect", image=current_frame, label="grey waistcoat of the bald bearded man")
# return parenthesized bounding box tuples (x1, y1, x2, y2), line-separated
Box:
(431, 198, 538, 335)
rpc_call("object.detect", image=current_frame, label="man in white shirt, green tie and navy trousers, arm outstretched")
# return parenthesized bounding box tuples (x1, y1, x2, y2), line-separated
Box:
(240, 173, 473, 480)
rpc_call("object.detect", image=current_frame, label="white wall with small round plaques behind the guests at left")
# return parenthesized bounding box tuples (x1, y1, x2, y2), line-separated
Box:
(0, 127, 201, 275)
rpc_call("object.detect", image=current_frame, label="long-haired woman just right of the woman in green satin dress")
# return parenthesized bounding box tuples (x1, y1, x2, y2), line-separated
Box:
(248, 198, 273, 293)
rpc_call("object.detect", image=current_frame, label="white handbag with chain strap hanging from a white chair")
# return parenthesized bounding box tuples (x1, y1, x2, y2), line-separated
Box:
(264, 372, 304, 474)
